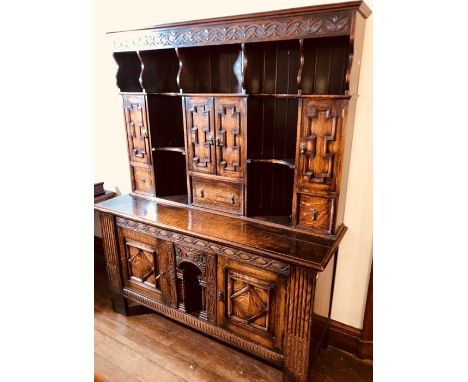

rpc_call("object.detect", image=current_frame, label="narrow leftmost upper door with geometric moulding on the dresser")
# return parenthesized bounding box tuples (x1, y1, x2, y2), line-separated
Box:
(123, 95, 152, 165)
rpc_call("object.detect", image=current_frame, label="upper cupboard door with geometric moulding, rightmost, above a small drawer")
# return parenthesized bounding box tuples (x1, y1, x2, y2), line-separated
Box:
(296, 99, 347, 192)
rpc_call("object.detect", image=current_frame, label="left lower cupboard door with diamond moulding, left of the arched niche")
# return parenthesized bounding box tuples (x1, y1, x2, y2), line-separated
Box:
(118, 227, 177, 307)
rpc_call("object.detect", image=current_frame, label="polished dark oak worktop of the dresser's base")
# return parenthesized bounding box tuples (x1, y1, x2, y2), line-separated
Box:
(95, 195, 339, 271)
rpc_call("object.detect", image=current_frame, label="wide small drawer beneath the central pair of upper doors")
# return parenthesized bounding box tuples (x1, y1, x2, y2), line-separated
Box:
(192, 176, 244, 215)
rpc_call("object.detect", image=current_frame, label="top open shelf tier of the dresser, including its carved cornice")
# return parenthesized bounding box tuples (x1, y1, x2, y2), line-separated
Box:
(109, 1, 370, 97)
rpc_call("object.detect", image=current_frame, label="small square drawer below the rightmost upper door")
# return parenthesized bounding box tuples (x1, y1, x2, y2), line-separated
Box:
(297, 194, 335, 235)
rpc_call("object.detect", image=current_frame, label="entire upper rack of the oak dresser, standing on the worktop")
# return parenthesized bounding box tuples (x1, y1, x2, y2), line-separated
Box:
(109, 2, 370, 237)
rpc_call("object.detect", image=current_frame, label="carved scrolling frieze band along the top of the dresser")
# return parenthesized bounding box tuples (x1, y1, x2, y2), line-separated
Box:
(109, 11, 352, 52)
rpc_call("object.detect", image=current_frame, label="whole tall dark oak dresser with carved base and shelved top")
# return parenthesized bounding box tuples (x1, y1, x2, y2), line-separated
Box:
(95, 1, 370, 381)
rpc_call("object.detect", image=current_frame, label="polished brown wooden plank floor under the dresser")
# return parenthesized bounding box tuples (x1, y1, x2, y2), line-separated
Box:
(94, 252, 372, 382)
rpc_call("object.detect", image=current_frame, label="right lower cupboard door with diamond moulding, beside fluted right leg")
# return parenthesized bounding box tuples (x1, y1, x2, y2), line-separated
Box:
(217, 256, 286, 352)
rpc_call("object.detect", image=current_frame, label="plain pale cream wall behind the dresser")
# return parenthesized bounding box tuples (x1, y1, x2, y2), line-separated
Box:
(94, 0, 372, 328)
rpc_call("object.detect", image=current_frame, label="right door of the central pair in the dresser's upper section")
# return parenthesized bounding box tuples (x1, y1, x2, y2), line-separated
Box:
(215, 97, 246, 179)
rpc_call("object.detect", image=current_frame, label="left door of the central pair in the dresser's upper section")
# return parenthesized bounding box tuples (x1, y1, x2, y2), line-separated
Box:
(185, 97, 216, 174)
